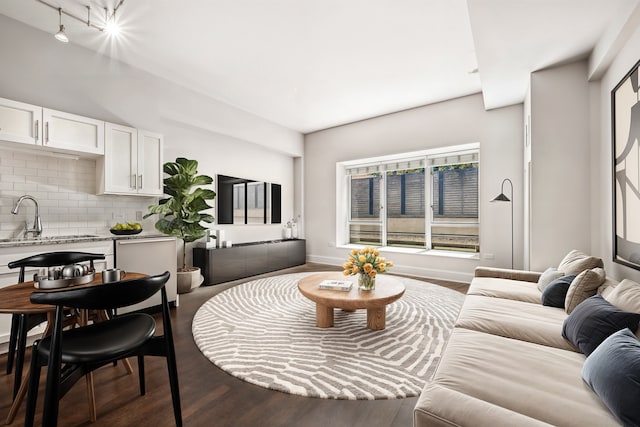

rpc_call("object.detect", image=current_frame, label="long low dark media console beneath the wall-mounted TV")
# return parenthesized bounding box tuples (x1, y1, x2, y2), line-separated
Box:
(193, 239, 306, 285)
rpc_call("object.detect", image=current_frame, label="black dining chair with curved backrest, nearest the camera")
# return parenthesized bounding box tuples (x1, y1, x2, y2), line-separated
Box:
(24, 272, 182, 427)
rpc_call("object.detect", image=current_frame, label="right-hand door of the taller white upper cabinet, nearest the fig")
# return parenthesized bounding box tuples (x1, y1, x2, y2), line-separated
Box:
(137, 129, 163, 196)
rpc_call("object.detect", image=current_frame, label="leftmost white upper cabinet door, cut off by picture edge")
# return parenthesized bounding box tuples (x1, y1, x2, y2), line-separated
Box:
(0, 98, 42, 145)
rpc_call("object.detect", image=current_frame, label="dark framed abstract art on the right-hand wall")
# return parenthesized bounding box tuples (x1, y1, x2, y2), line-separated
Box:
(611, 61, 640, 270)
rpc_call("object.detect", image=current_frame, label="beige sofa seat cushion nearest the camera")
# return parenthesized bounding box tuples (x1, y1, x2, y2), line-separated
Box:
(419, 328, 619, 427)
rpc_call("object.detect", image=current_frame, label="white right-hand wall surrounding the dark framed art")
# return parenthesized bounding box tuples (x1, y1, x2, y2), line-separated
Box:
(591, 23, 640, 282)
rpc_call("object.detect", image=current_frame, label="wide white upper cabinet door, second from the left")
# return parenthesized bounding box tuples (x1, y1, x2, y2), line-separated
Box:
(42, 108, 104, 155)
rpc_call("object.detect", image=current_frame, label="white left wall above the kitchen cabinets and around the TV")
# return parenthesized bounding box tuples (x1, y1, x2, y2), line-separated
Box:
(0, 15, 303, 264)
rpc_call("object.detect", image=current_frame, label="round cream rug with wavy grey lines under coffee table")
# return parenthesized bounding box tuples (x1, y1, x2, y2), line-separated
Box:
(192, 273, 464, 400)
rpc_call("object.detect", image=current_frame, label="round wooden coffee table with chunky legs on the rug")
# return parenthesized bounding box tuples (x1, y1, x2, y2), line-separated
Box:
(298, 272, 404, 331)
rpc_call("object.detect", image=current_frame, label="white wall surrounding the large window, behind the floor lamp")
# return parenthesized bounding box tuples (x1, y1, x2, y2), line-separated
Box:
(304, 94, 523, 280)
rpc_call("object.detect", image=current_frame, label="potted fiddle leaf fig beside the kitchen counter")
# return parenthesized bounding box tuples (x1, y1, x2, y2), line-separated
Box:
(144, 157, 216, 293)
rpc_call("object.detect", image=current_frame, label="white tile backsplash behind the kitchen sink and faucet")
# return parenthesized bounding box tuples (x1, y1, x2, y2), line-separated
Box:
(0, 147, 157, 239)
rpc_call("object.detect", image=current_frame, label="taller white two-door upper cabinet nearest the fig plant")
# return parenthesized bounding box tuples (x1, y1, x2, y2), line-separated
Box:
(97, 123, 163, 196)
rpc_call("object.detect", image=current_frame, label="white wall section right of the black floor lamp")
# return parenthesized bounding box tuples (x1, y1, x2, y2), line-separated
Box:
(525, 61, 592, 271)
